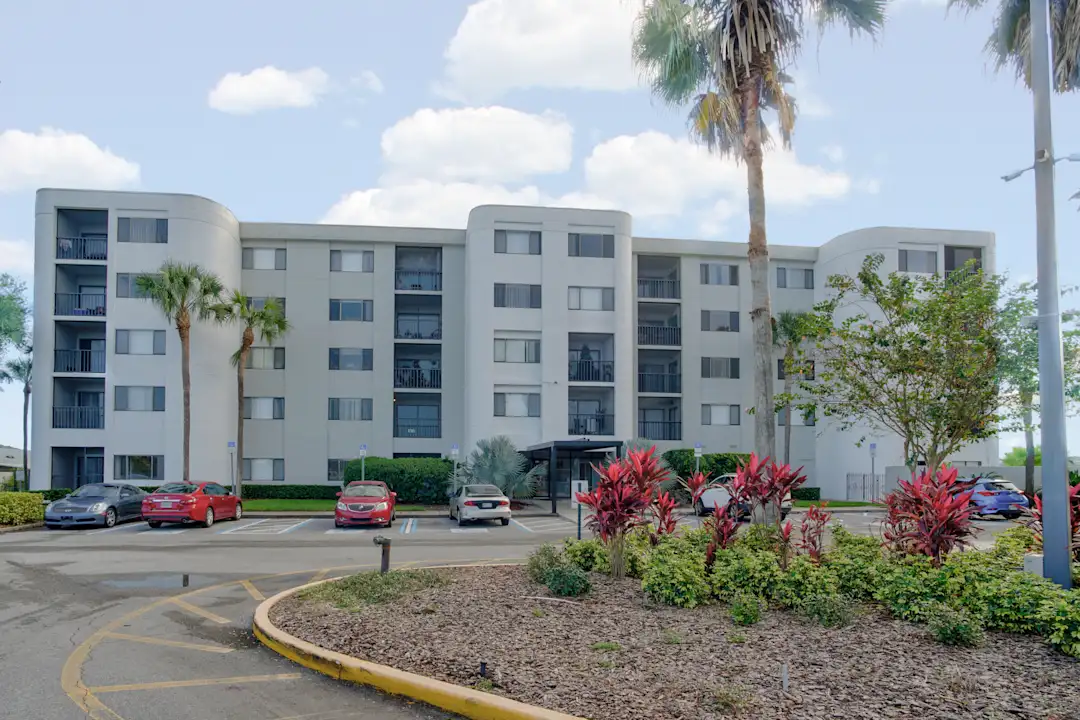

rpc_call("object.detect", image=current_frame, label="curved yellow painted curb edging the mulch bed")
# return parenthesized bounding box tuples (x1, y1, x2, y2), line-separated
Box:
(252, 566, 582, 720)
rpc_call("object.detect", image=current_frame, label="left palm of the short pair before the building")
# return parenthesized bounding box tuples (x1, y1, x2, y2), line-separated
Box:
(135, 260, 225, 483)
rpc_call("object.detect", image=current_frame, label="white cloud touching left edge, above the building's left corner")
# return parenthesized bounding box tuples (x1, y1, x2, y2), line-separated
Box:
(0, 127, 139, 192)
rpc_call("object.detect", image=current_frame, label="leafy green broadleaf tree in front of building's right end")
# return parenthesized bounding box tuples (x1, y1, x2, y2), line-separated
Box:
(795, 254, 1000, 467)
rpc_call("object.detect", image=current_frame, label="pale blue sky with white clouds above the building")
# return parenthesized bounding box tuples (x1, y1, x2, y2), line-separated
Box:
(0, 0, 1080, 454)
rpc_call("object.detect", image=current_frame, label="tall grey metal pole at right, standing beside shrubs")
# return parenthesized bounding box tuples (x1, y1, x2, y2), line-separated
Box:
(1030, 0, 1072, 588)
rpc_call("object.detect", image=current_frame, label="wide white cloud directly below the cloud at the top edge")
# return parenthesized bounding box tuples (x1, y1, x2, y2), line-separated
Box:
(382, 107, 573, 184)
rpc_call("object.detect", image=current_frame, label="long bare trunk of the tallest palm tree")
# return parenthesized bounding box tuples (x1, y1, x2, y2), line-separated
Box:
(742, 85, 777, 521)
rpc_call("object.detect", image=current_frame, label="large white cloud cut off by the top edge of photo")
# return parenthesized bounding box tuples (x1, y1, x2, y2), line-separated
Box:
(436, 0, 639, 101)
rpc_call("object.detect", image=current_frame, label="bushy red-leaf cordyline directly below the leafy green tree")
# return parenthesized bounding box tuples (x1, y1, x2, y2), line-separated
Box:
(882, 466, 975, 567)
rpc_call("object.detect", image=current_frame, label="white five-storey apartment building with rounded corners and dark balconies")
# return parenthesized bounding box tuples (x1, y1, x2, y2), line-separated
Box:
(31, 189, 997, 498)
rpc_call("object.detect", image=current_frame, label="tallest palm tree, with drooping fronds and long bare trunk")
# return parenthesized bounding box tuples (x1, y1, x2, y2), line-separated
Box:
(633, 0, 886, 456)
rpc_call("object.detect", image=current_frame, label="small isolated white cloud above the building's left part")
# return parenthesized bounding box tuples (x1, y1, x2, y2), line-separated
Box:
(206, 65, 330, 114)
